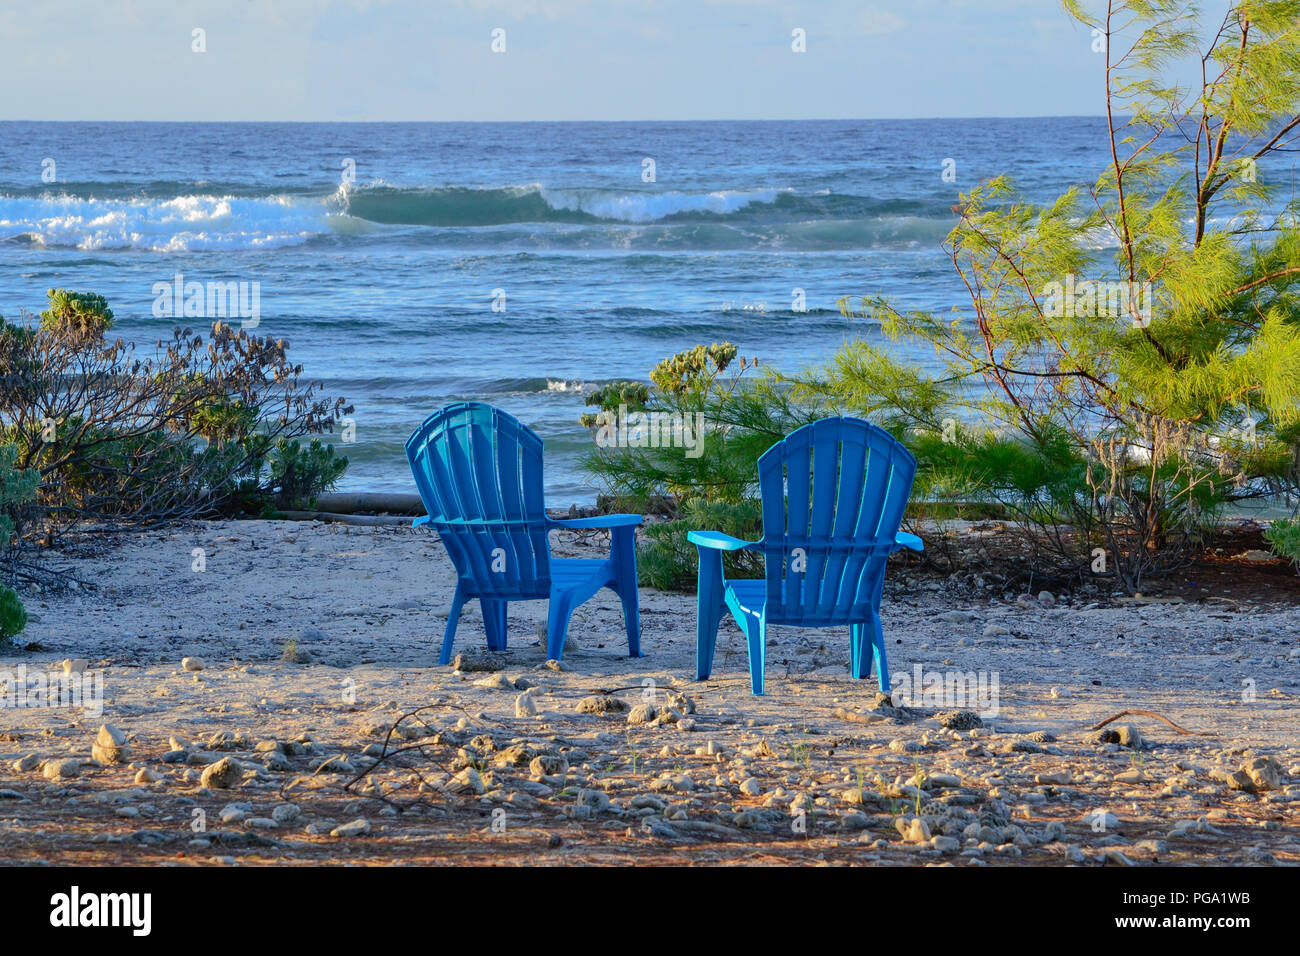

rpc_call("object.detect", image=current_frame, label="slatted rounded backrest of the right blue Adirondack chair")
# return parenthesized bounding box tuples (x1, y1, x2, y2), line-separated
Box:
(758, 418, 917, 626)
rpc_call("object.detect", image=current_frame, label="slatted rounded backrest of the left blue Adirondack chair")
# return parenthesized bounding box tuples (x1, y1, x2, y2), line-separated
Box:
(406, 402, 551, 598)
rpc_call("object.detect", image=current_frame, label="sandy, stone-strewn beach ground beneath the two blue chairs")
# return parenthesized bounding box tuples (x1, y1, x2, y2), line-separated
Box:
(0, 520, 1300, 866)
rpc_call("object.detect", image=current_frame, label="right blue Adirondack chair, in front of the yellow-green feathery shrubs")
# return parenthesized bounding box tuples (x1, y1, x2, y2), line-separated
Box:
(688, 418, 923, 695)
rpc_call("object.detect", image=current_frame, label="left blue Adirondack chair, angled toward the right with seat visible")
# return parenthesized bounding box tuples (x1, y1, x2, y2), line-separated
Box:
(406, 402, 641, 665)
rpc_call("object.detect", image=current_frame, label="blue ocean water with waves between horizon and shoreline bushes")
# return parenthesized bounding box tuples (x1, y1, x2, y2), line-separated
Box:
(0, 117, 1108, 507)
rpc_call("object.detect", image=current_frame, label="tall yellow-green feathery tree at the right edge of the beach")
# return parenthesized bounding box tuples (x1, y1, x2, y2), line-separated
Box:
(800, 0, 1300, 589)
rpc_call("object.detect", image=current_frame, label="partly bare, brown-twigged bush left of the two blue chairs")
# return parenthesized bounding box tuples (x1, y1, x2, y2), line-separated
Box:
(0, 289, 351, 544)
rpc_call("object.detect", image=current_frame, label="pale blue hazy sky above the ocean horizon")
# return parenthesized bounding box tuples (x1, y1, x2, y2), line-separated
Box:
(0, 0, 1227, 121)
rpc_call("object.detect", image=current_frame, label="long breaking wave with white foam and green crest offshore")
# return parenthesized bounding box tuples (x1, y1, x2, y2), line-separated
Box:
(0, 182, 952, 252)
